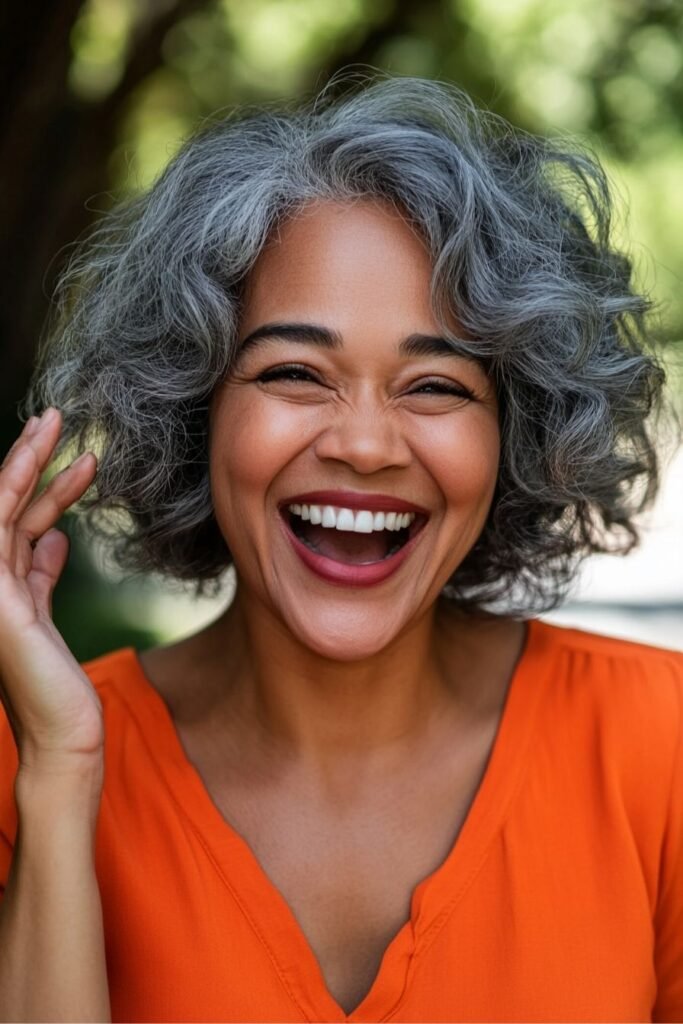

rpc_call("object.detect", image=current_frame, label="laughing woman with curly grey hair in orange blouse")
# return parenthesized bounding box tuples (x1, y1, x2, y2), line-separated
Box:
(0, 79, 683, 1021)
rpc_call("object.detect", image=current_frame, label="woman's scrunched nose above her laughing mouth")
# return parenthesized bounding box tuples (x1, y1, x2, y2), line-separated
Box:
(313, 398, 411, 473)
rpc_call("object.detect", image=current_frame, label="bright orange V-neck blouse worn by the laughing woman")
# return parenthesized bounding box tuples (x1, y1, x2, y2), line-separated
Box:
(0, 620, 683, 1021)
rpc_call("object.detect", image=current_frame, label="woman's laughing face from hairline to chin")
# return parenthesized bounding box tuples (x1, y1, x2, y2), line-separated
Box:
(210, 201, 500, 660)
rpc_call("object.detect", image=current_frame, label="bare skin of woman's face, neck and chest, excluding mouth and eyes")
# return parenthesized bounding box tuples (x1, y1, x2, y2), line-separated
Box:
(141, 201, 523, 1012)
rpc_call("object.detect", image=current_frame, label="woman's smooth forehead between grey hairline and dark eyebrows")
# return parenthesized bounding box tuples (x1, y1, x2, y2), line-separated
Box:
(241, 200, 444, 336)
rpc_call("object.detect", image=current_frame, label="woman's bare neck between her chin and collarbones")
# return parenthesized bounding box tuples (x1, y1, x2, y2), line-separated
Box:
(197, 587, 491, 764)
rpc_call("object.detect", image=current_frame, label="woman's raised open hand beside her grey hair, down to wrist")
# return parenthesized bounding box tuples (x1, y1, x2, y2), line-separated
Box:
(0, 409, 103, 774)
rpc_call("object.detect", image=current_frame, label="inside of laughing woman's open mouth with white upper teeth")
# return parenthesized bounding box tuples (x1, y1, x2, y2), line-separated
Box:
(280, 505, 427, 565)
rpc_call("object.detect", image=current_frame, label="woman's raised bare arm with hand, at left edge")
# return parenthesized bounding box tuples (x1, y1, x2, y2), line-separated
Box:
(0, 410, 111, 1021)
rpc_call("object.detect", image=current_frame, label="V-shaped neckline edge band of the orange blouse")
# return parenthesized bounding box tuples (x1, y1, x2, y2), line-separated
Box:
(121, 620, 552, 1022)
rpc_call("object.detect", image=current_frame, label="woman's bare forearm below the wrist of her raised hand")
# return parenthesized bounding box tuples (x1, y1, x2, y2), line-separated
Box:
(0, 771, 111, 1022)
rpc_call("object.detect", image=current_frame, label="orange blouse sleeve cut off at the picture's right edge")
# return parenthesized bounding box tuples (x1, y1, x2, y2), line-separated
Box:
(652, 657, 683, 1022)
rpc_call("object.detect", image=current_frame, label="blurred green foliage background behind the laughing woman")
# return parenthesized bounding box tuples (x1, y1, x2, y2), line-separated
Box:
(0, 0, 683, 659)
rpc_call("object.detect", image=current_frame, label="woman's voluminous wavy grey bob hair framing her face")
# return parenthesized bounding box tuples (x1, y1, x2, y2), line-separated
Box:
(20, 73, 665, 615)
